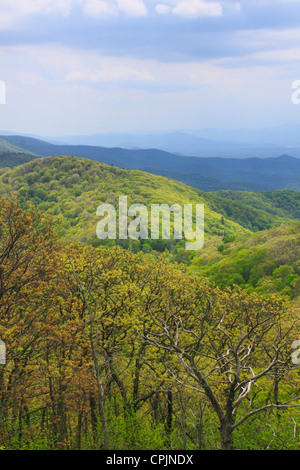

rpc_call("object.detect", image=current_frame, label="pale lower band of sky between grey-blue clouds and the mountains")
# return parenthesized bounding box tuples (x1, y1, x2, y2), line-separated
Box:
(0, 44, 299, 135)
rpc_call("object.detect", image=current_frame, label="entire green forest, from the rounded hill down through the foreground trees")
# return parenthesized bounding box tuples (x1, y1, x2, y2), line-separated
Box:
(0, 156, 300, 450)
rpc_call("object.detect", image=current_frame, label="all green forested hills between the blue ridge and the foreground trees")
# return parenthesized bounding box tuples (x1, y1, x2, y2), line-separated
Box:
(0, 156, 299, 280)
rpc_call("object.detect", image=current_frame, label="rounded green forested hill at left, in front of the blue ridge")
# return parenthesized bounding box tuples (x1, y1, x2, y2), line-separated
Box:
(0, 156, 247, 255)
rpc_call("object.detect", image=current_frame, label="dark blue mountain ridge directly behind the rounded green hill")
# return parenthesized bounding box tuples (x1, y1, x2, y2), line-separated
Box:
(0, 136, 300, 191)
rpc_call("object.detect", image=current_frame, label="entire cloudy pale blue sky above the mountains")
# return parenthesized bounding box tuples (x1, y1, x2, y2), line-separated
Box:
(0, 0, 300, 136)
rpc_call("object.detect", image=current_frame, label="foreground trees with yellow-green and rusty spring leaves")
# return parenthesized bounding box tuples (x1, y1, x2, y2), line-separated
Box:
(0, 198, 300, 450)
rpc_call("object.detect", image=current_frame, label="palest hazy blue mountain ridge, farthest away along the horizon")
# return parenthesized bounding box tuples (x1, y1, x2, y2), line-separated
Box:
(45, 129, 300, 158)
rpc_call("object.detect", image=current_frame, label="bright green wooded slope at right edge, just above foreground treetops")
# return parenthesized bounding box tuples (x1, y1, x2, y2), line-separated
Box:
(190, 222, 300, 298)
